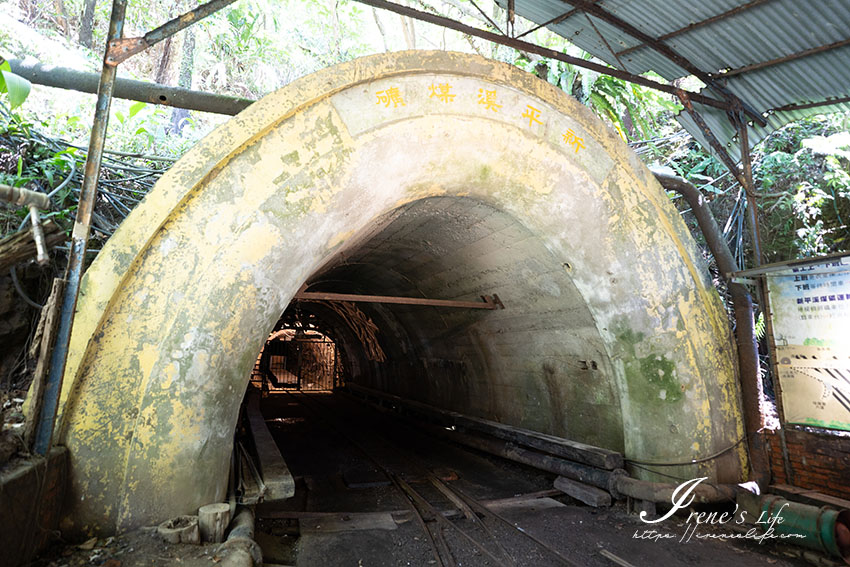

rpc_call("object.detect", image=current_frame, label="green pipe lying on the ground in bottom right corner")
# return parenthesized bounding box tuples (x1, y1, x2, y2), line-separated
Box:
(759, 495, 850, 565)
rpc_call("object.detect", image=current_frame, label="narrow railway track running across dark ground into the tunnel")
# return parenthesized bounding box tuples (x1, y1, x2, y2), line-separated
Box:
(287, 392, 578, 567)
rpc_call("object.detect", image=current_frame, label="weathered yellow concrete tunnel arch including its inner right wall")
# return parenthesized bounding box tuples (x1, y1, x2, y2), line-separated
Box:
(51, 52, 744, 533)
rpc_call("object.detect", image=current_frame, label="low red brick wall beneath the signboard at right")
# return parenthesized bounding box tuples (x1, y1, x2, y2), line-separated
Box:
(764, 428, 850, 499)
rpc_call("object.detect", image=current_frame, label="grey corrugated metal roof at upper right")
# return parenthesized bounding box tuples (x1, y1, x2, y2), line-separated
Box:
(497, 0, 850, 158)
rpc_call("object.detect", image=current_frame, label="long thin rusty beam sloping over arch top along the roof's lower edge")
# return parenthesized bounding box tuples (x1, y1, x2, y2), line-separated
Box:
(356, 0, 732, 110)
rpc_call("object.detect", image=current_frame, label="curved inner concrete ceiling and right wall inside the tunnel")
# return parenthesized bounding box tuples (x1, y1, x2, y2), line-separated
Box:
(298, 197, 608, 444)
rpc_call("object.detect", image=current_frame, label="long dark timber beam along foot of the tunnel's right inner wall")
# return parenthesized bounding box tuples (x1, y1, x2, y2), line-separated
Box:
(346, 383, 623, 470)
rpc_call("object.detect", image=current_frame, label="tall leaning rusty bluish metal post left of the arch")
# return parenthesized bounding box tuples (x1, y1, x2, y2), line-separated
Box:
(33, 0, 127, 455)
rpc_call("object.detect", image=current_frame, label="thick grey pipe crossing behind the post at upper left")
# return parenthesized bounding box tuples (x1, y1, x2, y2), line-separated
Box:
(8, 59, 254, 116)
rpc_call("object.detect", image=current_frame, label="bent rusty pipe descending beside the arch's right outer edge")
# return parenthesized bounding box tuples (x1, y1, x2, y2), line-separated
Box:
(653, 170, 770, 487)
